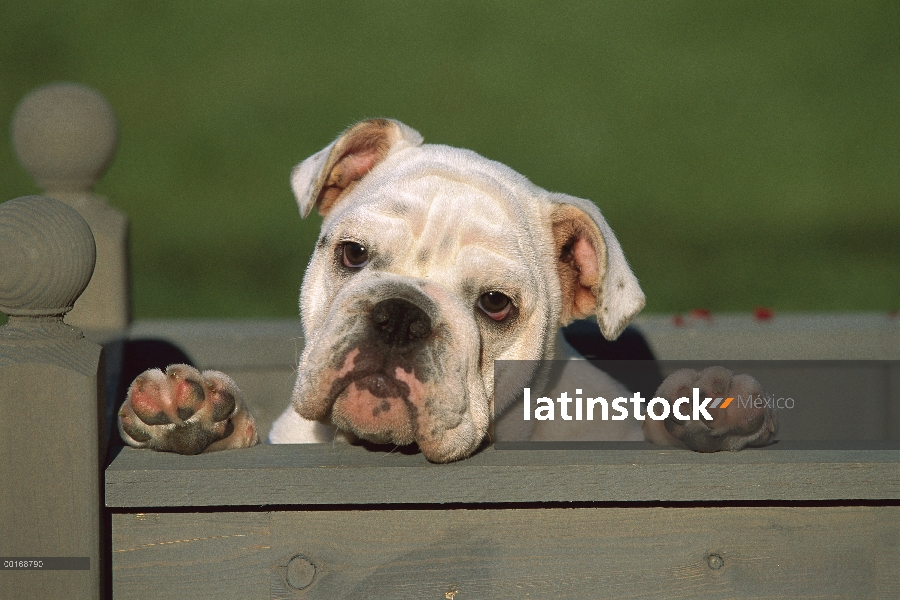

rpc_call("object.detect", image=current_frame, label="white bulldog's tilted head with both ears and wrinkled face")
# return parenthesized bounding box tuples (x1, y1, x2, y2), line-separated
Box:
(291, 119, 644, 462)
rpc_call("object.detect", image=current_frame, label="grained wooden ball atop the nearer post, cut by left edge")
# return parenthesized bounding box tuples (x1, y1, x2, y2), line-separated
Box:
(0, 196, 97, 317)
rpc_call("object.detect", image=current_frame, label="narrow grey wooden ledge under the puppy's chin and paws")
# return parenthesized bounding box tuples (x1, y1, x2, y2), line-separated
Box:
(106, 442, 900, 509)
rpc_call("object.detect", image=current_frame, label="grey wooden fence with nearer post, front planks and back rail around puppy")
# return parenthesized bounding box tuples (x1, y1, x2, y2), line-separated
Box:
(0, 83, 900, 600)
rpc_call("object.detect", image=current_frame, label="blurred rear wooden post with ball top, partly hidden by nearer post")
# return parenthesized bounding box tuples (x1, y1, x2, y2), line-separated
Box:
(11, 83, 131, 339)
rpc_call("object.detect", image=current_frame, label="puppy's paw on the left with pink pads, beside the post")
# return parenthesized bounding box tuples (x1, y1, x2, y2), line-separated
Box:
(119, 365, 259, 454)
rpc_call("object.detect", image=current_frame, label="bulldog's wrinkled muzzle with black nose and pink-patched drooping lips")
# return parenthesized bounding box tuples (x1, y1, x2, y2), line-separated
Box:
(294, 281, 489, 462)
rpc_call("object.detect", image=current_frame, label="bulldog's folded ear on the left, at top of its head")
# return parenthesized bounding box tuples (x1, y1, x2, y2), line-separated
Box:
(291, 119, 422, 217)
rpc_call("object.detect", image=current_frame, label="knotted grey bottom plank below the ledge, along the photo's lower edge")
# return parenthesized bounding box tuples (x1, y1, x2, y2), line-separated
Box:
(113, 506, 900, 600)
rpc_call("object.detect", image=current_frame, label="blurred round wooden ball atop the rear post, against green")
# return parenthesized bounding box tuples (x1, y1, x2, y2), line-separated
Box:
(11, 83, 118, 194)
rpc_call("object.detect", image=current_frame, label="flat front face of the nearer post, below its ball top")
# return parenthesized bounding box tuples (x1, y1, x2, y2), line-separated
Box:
(0, 340, 108, 600)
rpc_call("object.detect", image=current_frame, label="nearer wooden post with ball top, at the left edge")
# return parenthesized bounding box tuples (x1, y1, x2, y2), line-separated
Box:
(0, 196, 106, 599)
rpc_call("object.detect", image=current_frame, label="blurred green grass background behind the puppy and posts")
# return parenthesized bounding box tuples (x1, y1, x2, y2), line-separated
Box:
(0, 0, 900, 318)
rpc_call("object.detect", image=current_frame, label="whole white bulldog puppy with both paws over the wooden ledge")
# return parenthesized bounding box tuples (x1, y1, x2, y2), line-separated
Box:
(119, 119, 775, 462)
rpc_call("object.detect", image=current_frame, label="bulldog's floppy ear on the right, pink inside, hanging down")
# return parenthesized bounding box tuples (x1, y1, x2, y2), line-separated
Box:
(550, 194, 645, 340)
